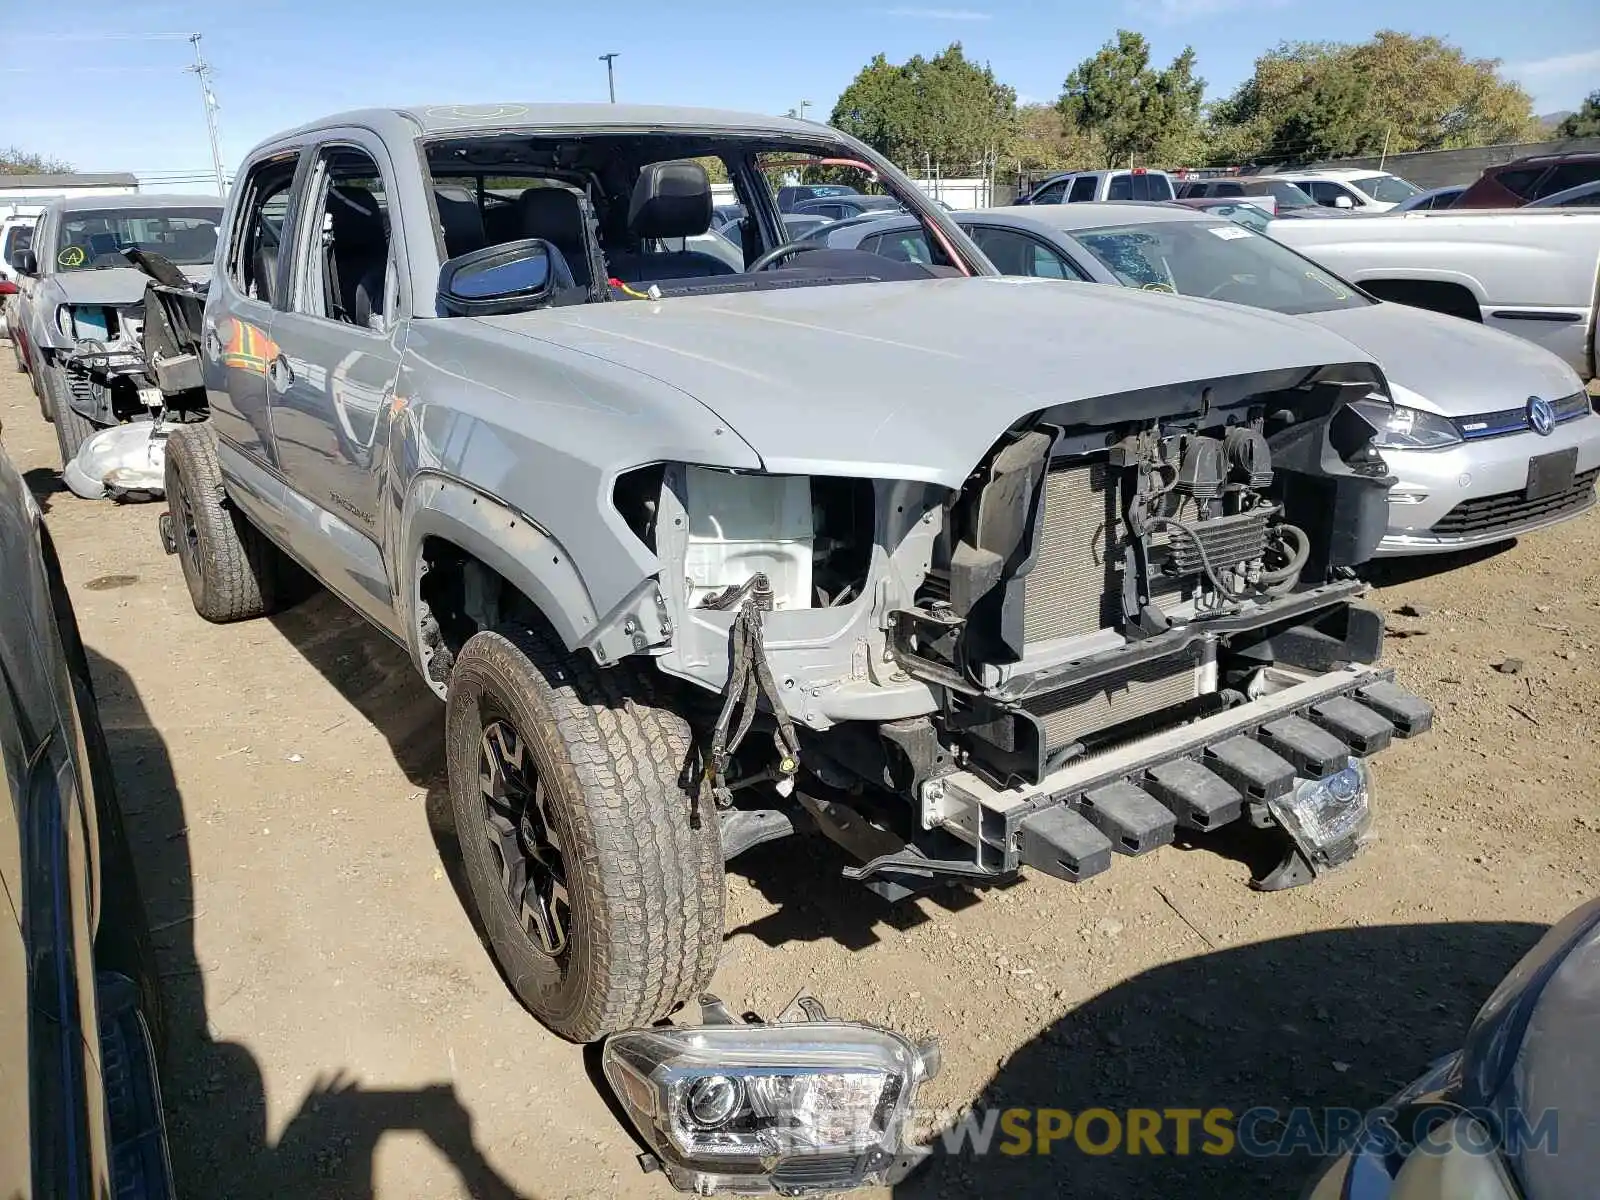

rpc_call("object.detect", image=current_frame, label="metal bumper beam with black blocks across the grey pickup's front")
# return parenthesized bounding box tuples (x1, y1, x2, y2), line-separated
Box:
(922, 666, 1434, 883)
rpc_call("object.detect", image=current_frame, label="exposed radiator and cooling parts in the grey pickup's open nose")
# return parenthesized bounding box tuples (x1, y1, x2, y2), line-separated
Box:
(896, 392, 1389, 781)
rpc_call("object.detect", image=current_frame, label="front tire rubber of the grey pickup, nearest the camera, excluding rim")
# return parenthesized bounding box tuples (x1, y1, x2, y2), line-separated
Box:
(445, 627, 726, 1042)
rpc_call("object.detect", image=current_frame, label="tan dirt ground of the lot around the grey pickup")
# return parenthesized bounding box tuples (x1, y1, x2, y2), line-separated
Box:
(0, 366, 1600, 1200)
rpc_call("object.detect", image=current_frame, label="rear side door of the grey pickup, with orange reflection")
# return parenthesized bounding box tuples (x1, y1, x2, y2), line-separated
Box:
(200, 150, 301, 467)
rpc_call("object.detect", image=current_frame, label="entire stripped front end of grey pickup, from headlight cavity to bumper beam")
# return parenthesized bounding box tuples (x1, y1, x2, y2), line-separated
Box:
(659, 374, 1430, 894)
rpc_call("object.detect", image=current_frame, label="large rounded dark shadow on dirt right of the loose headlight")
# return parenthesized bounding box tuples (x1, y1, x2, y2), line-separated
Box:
(894, 922, 1544, 1200)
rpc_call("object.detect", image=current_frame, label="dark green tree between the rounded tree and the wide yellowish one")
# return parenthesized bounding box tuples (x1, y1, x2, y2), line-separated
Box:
(1056, 29, 1205, 166)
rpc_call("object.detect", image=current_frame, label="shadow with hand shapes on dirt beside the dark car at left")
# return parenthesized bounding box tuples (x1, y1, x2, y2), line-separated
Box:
(88, 650, 531, 1200)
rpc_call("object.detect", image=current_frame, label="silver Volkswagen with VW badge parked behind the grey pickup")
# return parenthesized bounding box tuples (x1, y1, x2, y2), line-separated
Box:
(814, 203, 1600, 555)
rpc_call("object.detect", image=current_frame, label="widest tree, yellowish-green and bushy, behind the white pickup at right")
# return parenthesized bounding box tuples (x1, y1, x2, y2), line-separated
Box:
(1208, 30, 1538, 163)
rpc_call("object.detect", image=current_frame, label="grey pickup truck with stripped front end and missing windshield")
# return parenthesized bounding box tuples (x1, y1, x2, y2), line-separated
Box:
(156, 106, 1432, 1068)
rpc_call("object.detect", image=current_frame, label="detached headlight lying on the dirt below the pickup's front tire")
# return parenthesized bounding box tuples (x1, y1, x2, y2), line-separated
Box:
(602, 1021, 938, 1195)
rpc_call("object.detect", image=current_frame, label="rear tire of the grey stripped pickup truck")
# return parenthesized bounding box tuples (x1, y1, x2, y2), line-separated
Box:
(166, 422, 286, 624)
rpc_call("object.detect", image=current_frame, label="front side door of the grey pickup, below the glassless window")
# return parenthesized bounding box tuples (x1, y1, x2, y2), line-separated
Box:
(267, 131, 406, 627)
